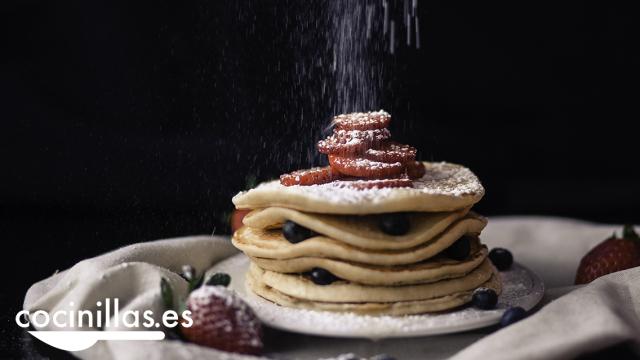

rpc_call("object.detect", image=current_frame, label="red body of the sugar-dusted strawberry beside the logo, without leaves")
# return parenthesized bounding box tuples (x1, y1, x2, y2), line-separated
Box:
(181, 285, 263, 355)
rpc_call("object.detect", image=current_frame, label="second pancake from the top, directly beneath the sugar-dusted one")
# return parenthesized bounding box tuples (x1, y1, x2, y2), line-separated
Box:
(243, 207, 469, 250)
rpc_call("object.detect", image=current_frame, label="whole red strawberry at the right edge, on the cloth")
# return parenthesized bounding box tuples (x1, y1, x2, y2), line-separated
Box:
(576, 225, 640, 285)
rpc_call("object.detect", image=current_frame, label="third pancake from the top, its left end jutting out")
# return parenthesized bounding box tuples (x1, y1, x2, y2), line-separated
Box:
(231, 214, 487, 266)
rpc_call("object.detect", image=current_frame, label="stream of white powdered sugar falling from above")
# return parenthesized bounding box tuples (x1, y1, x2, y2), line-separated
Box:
(329, 0, 420, 114)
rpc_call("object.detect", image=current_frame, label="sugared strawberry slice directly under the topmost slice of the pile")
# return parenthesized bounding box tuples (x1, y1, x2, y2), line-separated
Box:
(318, 129, 391, 156)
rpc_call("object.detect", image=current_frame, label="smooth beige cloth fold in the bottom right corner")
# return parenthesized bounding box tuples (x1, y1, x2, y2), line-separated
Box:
(453, 268, 640, 360)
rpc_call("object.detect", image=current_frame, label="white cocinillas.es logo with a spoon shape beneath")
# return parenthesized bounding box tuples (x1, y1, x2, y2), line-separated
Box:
(15, 298, 193, 351)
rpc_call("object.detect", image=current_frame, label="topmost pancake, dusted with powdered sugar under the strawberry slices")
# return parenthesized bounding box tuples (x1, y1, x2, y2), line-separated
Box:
(233, 162, 484, 215)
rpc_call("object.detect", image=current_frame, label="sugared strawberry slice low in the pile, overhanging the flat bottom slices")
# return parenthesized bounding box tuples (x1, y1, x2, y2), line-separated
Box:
(329, 155, 404, 178)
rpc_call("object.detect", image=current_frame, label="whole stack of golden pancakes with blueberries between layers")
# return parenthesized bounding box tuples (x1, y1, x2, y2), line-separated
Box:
(232, 162, 501, 315)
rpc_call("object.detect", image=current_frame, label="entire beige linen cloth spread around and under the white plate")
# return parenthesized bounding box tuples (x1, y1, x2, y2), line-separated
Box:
(24, 217, 640, 360)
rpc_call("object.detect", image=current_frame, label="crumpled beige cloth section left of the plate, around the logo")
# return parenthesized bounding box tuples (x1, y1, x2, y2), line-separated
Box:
(23, 236, 264, 359)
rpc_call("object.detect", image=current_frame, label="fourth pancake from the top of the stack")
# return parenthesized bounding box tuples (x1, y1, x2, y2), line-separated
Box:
(251, 246, 487, 286)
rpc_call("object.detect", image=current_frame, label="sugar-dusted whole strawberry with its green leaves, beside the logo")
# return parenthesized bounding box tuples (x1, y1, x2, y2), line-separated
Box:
(160, 267, 263, 355)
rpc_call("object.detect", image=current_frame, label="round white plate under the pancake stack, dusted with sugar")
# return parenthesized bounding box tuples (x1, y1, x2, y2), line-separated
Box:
(210, 254, 544, 339)
